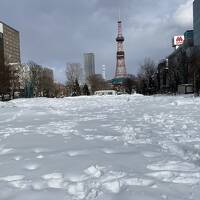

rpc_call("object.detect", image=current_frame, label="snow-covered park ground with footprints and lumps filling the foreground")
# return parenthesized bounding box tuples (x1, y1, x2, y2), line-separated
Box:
(0, 95, 200, 200)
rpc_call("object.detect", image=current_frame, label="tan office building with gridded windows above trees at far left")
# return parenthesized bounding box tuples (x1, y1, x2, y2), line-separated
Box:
(0, 21, 21, 63)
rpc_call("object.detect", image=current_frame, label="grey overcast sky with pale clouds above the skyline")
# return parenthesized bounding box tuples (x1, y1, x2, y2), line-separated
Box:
(0, 0, 193, 82)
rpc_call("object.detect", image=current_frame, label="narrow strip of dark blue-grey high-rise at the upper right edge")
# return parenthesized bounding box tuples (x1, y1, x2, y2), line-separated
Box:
(193, 0, 200, 46)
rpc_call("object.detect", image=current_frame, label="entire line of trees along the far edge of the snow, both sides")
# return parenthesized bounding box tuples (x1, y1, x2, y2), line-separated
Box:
(0, 52, 200, 99)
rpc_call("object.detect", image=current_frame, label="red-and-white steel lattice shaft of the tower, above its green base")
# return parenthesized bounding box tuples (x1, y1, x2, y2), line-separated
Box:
(115, 20, 127, 78)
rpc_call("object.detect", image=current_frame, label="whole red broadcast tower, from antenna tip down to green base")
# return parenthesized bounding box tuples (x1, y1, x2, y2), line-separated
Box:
(112, 11, 127, 91)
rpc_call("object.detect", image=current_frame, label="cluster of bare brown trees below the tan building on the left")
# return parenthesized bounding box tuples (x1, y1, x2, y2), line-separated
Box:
(0, 61, 61, 100)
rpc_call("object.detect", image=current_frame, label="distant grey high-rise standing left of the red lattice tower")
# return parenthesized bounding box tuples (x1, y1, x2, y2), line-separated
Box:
(84, 53, 95, 80)
